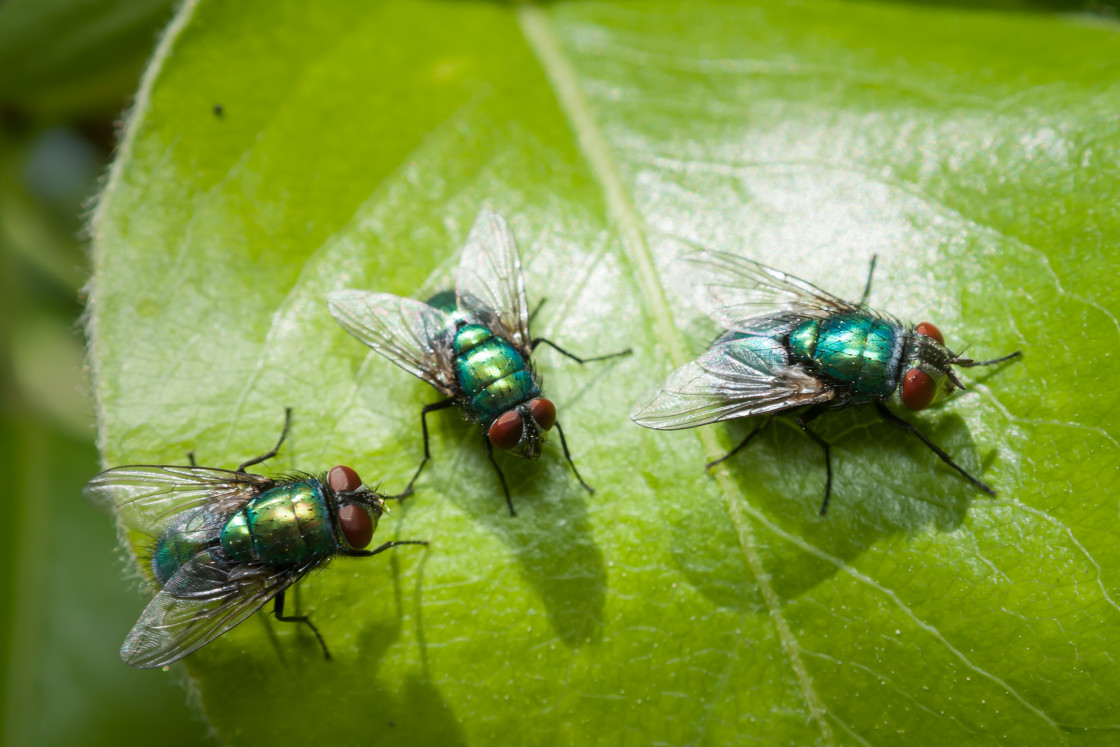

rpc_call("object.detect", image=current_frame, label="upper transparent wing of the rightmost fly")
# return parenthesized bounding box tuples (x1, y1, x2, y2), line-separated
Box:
(685, 251, 855, 333)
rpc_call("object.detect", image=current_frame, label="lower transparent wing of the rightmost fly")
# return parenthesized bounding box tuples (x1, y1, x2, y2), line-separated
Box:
(631, 343, 833, 430)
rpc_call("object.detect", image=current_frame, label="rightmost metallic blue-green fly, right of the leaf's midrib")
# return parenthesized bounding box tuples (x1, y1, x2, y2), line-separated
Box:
(631, 252, 1019, 514)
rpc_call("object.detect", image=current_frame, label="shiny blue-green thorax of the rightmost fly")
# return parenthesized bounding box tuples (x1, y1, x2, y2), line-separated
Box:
(790, 314, 903, 402)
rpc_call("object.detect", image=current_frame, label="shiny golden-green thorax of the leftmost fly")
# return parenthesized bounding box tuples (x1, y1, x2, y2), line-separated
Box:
(222, 480, 337, 566)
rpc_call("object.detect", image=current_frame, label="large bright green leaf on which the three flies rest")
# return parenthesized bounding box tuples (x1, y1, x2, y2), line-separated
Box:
(91, 2, 1120, 745)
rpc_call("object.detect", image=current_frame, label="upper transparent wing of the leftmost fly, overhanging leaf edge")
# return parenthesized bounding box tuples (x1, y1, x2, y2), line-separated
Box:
(82, 465, 273, 536)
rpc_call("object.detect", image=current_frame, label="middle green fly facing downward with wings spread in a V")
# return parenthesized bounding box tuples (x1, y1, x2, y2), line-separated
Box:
(328, 211, 629, 515)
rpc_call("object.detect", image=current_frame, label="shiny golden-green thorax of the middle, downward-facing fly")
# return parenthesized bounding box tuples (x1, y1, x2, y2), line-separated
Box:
(455, 325, 540, 422)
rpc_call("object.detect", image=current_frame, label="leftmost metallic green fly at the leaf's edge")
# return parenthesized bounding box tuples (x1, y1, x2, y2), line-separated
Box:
(84, 411, 427, 669)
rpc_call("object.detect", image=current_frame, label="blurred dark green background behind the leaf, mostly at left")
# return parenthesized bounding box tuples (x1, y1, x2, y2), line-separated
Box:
(0, 0, 1118, 746)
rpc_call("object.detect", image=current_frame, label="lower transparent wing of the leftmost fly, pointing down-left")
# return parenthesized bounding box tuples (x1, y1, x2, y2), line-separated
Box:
(121, 550, 318, 669)
